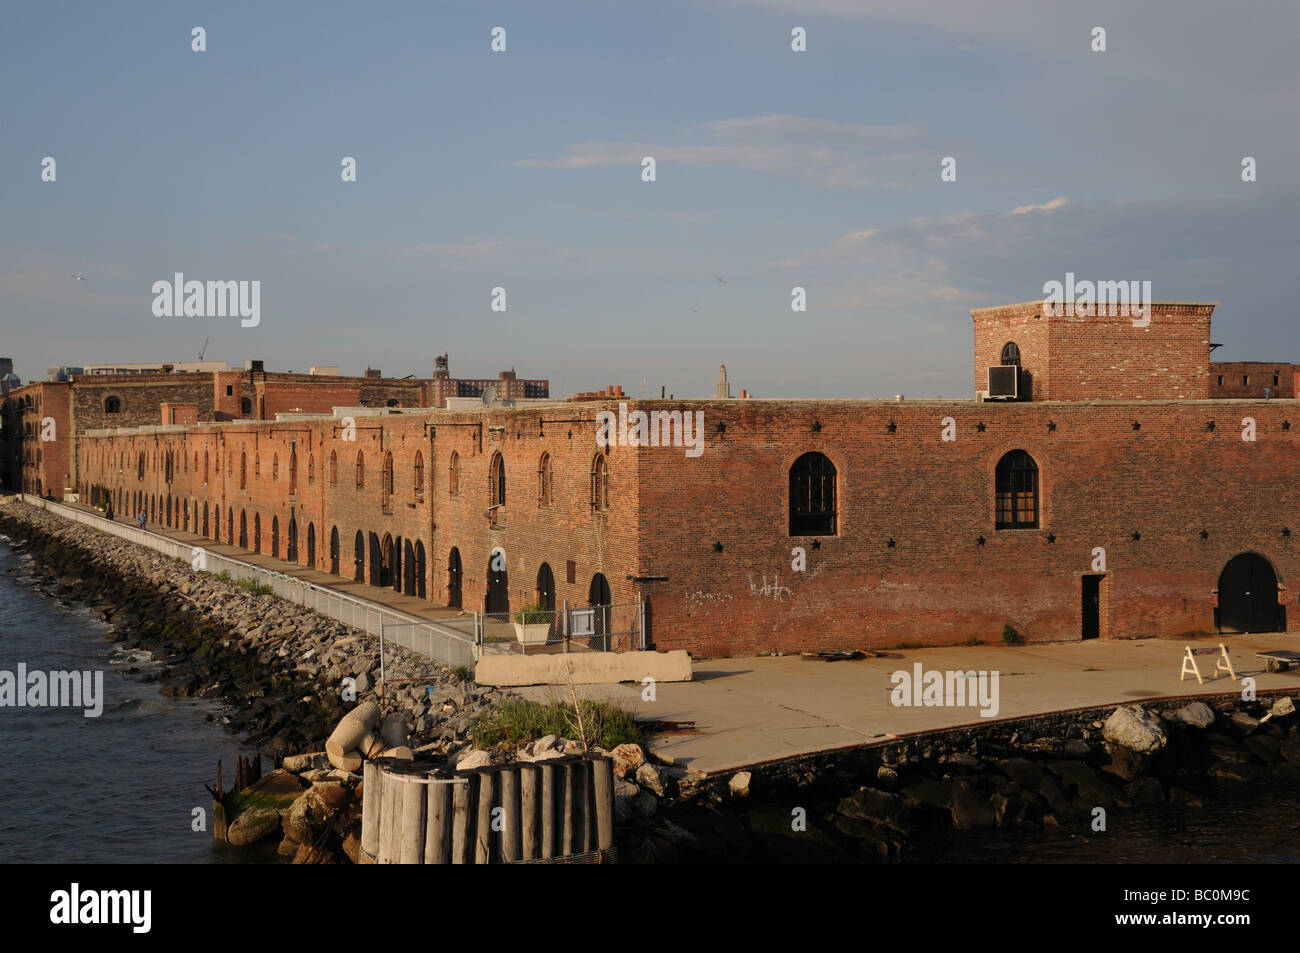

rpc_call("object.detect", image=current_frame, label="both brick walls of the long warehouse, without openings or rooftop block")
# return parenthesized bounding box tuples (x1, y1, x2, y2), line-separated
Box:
(73, 400, 1300, 655)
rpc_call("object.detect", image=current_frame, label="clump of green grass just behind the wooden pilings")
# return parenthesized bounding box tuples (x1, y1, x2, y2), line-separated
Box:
(469, 697, 641, 750)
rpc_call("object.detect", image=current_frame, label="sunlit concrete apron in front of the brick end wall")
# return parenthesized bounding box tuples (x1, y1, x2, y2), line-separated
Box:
(516, 633, 1300, 774)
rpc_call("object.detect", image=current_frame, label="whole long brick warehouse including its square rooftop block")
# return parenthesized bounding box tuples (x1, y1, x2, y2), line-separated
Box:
(58, 302, 1300, 655)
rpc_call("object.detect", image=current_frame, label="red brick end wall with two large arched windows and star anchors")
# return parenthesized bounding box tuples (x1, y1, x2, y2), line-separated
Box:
(626, 400, 1300, 654)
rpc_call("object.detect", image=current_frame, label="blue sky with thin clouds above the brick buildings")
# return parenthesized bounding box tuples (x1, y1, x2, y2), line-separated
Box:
(0, 0, 1300, 398)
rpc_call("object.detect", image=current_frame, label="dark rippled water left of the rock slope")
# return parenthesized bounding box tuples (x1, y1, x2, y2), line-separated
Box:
(0, 537, 273, 863)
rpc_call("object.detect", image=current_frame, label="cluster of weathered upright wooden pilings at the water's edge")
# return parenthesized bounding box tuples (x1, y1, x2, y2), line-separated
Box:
(361, 757, 614, 863)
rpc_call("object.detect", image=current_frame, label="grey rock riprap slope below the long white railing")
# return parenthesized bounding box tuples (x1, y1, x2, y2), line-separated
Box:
(0, 503, 503, 761)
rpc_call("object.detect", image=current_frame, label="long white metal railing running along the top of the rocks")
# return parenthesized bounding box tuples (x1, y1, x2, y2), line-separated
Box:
(22, 494, 478, 667)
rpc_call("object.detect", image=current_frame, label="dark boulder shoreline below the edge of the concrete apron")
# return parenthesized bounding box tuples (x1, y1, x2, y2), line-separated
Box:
(644, 694, 1300, 862)
